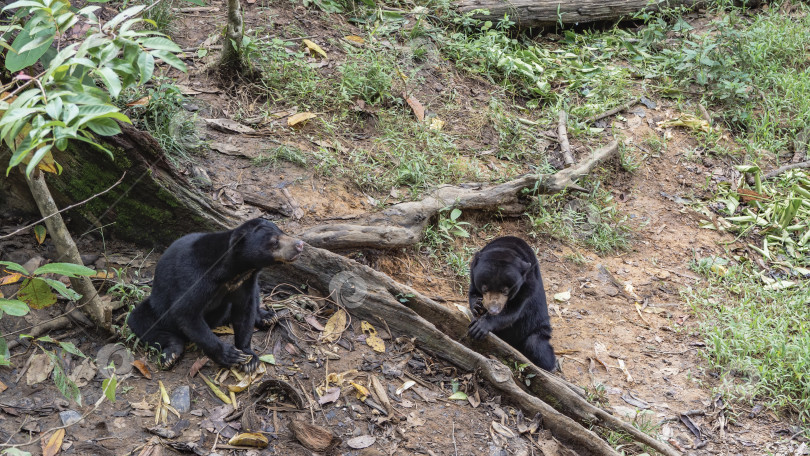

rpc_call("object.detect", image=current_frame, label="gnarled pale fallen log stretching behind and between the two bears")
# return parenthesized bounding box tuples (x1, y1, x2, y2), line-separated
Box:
(298, 141, 619, 250)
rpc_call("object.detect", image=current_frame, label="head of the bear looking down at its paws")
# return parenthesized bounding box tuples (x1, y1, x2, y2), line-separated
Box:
(470, 249, 532, 315)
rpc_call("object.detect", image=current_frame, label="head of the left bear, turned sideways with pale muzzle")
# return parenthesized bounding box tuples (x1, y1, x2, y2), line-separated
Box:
(230, 218, 304, 268)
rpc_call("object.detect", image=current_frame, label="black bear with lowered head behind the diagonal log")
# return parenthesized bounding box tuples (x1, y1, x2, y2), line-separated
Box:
(469, 236, 557, 371)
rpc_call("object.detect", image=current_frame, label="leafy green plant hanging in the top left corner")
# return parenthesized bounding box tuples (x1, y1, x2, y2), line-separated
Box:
(0, 0, 185, 175)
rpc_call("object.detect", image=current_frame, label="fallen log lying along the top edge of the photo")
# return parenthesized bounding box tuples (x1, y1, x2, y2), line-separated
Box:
(456, 0, 760, 27)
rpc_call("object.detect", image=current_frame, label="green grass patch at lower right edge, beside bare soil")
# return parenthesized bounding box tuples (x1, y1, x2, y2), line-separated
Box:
(686, 258, 810, 426)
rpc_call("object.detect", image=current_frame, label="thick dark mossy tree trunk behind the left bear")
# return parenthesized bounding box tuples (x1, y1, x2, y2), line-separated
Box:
(0, 124, 239, 246)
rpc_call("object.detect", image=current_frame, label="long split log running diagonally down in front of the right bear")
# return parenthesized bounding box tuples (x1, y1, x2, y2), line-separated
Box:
(264, 246, 679, 456)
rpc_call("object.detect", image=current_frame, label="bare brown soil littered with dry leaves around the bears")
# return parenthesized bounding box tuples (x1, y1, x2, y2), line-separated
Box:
(0, 1, 795, 455)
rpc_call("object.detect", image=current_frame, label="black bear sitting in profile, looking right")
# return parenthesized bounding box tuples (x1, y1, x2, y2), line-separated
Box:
(127, 219, 304, 372)
